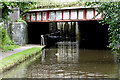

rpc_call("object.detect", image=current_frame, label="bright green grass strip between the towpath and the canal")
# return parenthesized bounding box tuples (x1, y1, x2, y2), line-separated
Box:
(0, 47, 42, 71)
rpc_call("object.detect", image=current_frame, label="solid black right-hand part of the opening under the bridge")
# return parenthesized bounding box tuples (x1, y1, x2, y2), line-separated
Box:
(78, 20, 108, 49)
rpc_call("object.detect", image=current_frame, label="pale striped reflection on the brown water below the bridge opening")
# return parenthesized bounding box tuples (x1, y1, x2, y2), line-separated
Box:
(56, 42, 79, 63)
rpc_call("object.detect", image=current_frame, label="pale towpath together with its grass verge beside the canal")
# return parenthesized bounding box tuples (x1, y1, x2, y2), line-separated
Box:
(0, 45, 45, 73)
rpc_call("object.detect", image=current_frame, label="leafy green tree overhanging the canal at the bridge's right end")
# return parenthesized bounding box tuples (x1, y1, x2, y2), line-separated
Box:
(85, 2, 120, 60)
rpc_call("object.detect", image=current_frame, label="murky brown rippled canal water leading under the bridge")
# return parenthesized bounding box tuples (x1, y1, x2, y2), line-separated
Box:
(0, 42, 118, 78)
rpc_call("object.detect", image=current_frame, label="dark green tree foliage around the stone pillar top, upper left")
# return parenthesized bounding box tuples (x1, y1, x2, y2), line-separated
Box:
(1, 2, 35, 20)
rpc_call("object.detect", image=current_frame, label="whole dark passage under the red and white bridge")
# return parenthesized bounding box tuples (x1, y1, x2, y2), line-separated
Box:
(28, 20, 108, 49)
